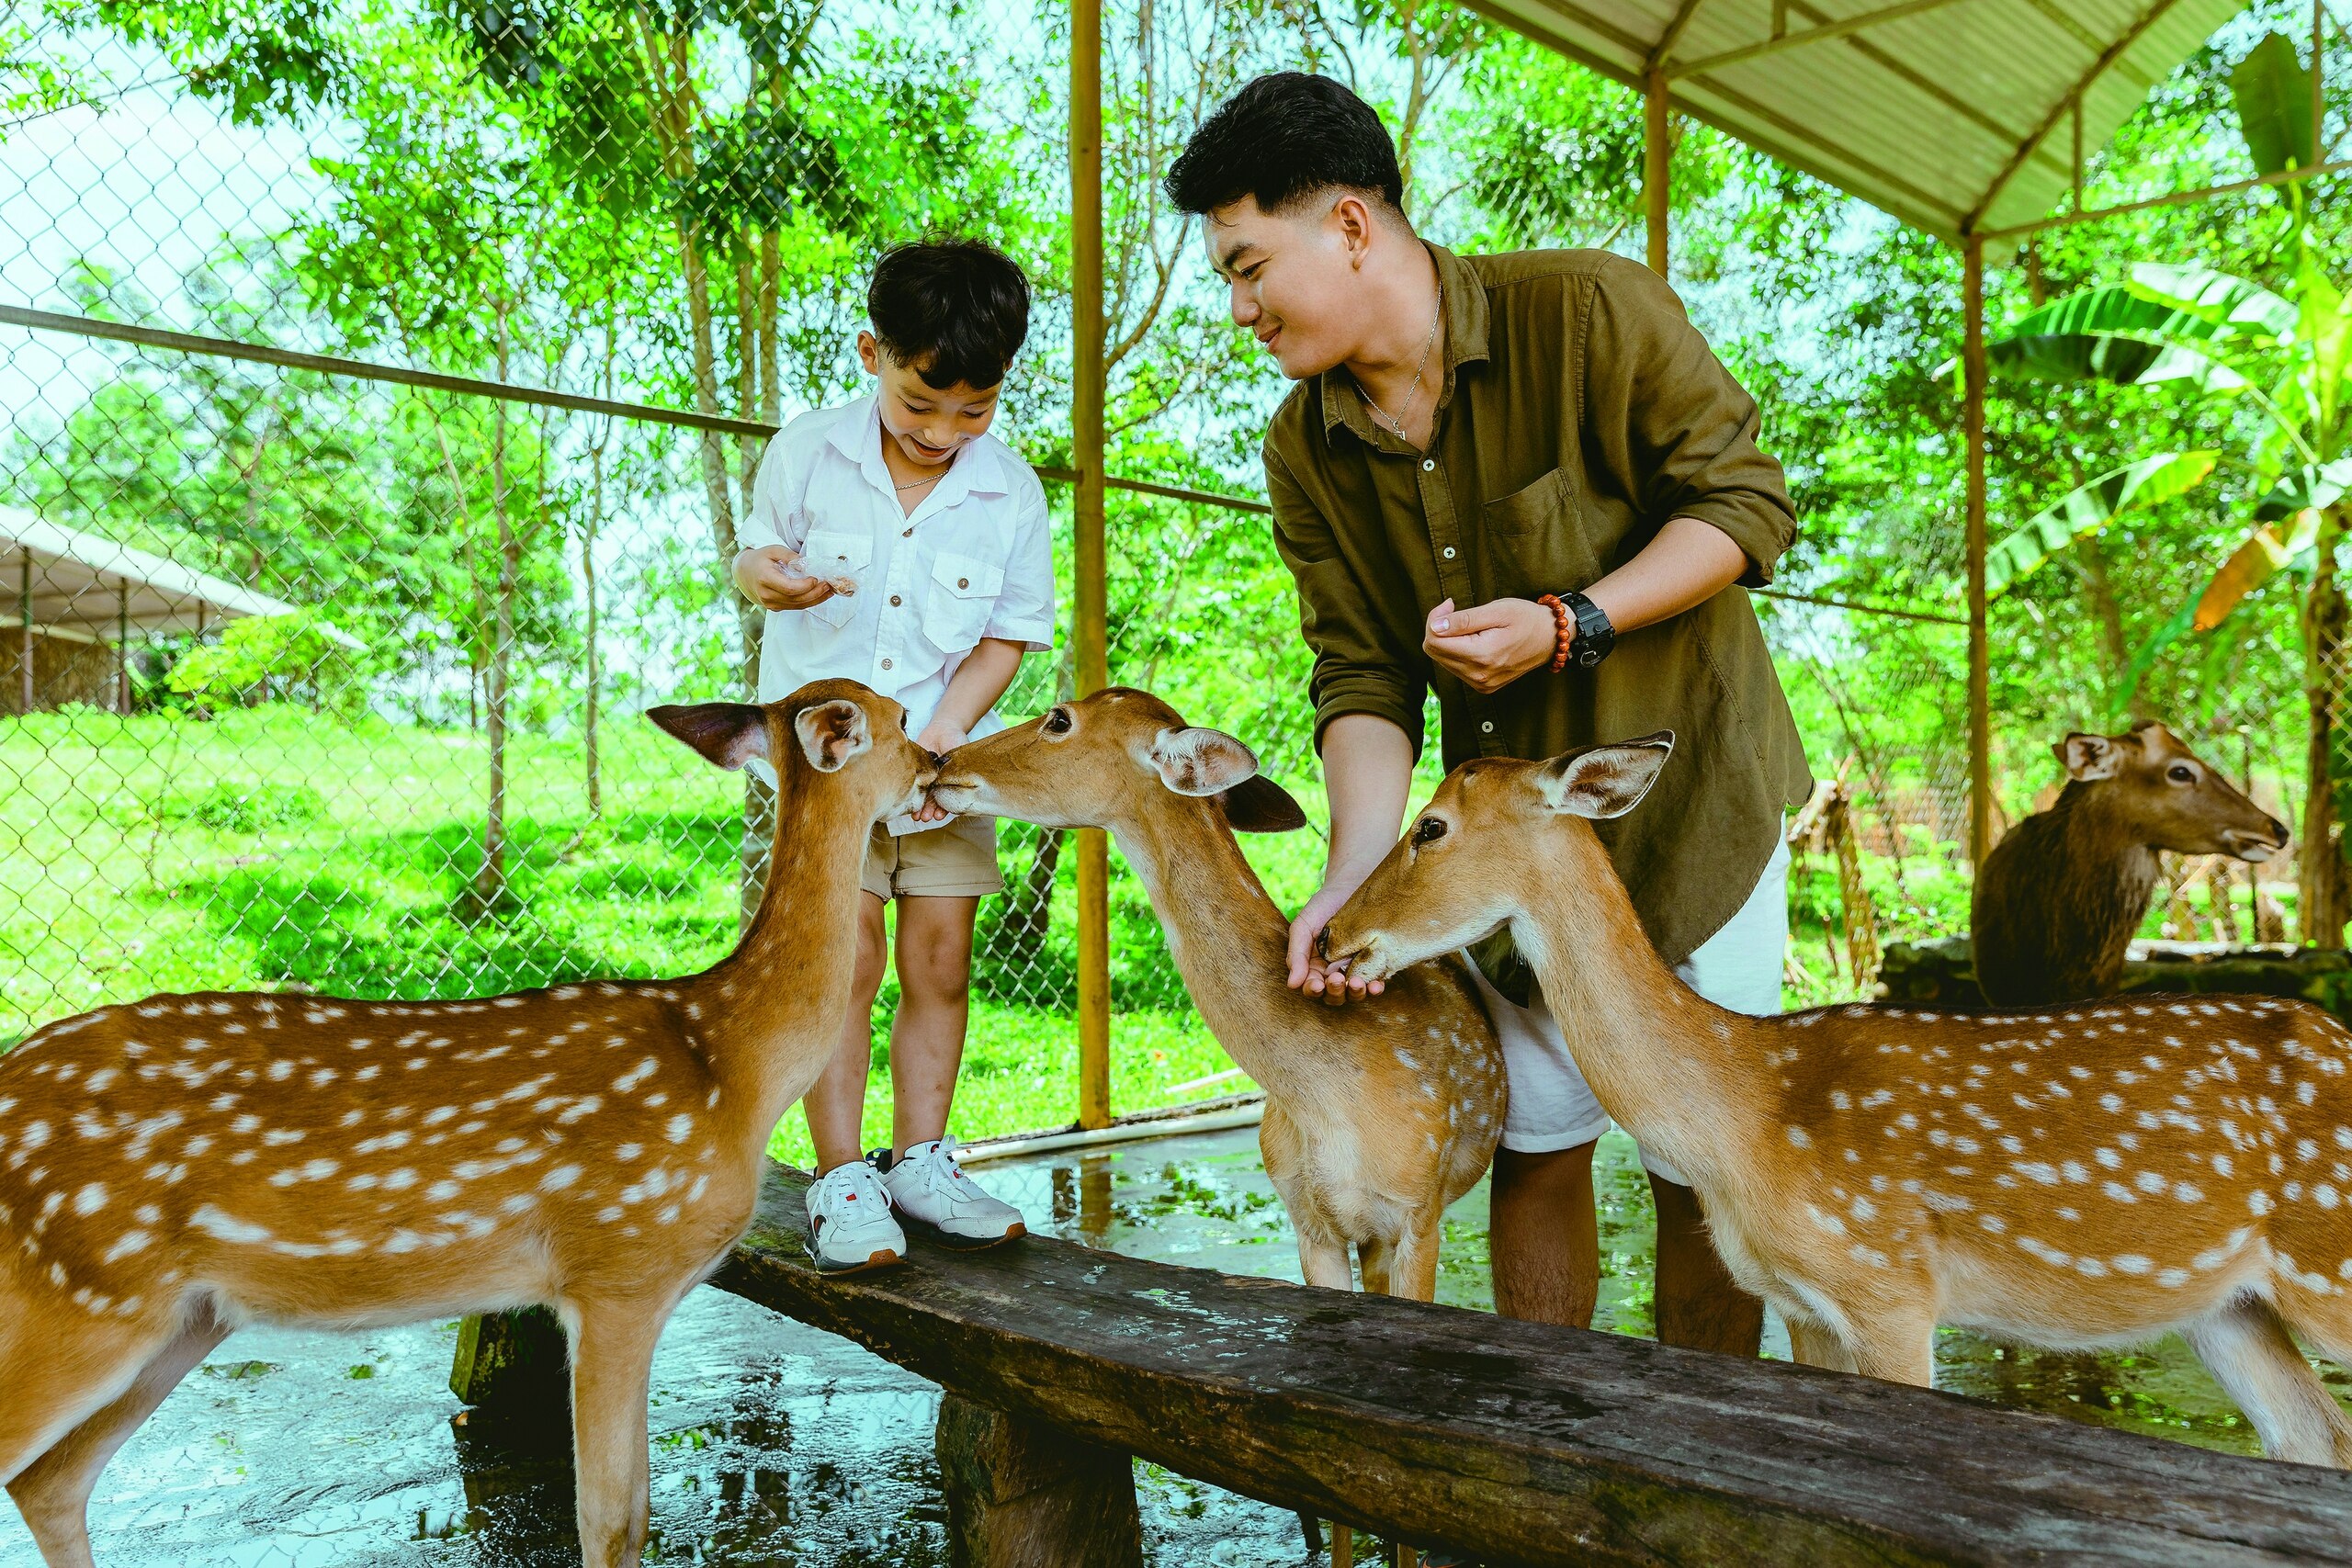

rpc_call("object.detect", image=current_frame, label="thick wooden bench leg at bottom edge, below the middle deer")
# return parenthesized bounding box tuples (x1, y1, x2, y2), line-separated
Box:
(938, 1394, 1143, 1568)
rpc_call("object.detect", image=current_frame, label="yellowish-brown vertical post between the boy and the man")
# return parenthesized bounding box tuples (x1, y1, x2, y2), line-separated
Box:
(1070, 0, 1110, 1128)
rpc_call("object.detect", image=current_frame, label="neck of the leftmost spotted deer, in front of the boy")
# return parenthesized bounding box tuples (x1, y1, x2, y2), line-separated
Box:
(680, 778, 870, 1147)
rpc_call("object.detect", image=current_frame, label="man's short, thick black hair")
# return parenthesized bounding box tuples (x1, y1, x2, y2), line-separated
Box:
(1167, 71, 1404, 214)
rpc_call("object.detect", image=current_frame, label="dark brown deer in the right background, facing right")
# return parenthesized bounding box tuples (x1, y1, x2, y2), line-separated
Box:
(1969, 719, 2286, 1006)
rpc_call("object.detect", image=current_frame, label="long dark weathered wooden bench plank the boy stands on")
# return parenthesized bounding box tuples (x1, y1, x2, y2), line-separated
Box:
(713, 1166, 2352, 1568)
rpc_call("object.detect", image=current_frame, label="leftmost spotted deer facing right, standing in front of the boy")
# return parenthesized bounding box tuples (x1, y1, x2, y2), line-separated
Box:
(0, 682, 933, 1568)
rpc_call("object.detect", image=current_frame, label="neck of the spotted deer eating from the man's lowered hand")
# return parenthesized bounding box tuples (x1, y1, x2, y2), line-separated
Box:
(1510, 820, 1771, 1182)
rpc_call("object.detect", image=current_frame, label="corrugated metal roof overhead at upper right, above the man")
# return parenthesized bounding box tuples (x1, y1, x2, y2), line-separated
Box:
(1470, 0, 2244, 243)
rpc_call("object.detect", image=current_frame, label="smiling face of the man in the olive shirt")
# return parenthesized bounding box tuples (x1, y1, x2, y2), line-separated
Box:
(1202, 193, 1369, 381)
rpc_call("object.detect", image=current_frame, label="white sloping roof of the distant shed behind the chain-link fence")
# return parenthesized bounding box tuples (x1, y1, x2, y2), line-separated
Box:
(0, 508, 360, 647)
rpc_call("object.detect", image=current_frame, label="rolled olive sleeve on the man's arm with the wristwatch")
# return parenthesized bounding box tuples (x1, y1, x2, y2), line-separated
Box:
(1583, 259, 1797, 588)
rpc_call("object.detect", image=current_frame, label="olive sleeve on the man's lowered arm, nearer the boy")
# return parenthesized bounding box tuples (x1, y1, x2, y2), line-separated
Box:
(1265, 445, 1428, 757)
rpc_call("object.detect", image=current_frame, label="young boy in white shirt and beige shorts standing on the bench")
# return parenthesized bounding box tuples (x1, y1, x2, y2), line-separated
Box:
(734, 240, 1054, 1272)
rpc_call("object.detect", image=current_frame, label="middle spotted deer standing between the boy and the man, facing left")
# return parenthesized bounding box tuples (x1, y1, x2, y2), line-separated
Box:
(932, 686, 1503, 1300)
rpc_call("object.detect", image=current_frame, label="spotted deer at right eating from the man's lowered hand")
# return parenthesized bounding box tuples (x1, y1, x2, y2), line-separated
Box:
(1324, 733, 2352, 1464)
